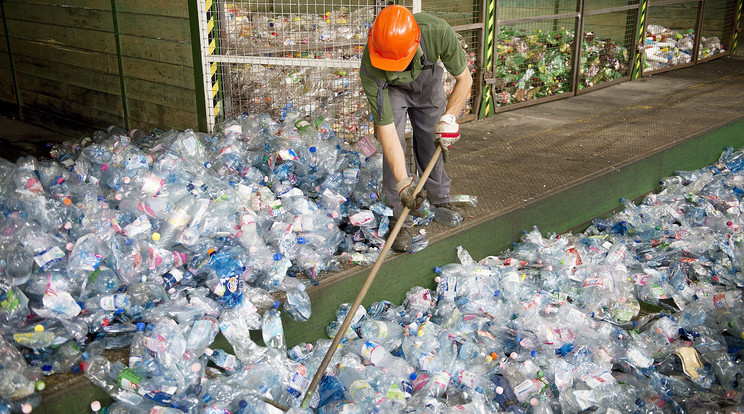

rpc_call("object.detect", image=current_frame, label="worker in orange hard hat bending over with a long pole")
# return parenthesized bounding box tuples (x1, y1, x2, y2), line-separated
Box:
(360, 5, 473, 251)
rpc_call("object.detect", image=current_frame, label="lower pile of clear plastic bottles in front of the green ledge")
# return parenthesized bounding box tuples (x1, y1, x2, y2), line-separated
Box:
(87, 146, 744, 413)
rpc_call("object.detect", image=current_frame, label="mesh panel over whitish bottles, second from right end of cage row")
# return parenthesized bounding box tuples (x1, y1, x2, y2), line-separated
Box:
(641, 0, 700, 74)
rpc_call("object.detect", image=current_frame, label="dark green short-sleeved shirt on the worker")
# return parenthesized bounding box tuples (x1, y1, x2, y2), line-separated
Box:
(359, 13, 467, 125)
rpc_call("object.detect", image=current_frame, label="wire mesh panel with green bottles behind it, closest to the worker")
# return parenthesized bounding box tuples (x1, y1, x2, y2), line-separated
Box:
(494, 17, 576, 107)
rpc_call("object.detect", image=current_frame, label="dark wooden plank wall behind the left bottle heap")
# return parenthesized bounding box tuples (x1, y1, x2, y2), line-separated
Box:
(0, 0, 197, 136)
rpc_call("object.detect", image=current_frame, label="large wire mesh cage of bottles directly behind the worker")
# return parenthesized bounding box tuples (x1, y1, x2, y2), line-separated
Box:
(202, 0, 479, 143)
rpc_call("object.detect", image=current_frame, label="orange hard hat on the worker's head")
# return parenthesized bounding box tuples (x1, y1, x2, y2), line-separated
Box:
(367, 5, 421, 72)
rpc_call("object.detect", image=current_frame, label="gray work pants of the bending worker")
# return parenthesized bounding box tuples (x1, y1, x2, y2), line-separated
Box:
(382, 65, 450, 218)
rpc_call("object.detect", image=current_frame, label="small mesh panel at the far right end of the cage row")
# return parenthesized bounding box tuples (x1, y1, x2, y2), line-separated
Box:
(698, 0, 736, 60)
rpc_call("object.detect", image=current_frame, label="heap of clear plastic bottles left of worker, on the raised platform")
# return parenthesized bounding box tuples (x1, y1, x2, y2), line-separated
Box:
(0, 111, 462, 408)
